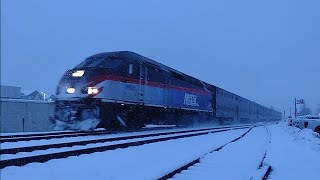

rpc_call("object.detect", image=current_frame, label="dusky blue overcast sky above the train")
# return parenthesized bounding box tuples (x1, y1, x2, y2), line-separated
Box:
(1, 0, 320, 114)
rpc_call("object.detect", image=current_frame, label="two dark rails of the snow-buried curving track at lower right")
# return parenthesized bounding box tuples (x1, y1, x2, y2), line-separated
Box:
(158, 126, 272, 180)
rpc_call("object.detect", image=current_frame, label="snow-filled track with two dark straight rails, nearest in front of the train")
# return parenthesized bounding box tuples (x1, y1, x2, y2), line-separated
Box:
(0, 125, 250, 169)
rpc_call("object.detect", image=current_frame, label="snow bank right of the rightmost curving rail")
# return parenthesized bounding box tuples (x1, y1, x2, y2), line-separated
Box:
(265, 124, 320, 180)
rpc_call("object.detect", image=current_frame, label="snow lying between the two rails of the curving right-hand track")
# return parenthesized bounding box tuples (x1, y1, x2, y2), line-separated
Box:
(162, 127, 270, 180)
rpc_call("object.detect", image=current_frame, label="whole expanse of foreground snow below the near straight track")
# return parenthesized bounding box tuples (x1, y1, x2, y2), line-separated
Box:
(1, 124, 320, 180)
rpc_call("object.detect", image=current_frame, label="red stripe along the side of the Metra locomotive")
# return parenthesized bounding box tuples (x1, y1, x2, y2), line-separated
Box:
(89, 75, 210, 95)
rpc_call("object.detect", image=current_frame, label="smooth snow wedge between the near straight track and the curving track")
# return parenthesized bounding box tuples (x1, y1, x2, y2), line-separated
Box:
(1, 129, 247, 180)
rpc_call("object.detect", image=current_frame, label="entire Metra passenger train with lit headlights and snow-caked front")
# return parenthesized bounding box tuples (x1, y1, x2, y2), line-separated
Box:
(55, 51, 281, 130)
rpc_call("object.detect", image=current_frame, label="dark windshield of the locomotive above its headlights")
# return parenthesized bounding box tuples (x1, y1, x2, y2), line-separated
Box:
(75, 56, 123, 69)
